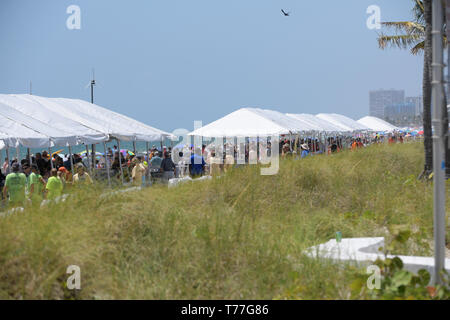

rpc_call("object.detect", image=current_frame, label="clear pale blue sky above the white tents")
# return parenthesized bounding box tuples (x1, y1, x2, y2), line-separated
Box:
(0, 0, 423, 131)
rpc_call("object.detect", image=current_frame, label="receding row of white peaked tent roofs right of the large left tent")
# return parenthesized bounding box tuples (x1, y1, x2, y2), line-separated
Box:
(189, 108, 399, 138)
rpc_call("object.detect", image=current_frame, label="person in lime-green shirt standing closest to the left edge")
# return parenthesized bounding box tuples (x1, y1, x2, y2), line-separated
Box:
(3, 162, 27, 207)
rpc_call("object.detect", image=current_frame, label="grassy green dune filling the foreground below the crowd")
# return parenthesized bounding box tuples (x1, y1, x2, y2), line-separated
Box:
(0, 143, 446, 299)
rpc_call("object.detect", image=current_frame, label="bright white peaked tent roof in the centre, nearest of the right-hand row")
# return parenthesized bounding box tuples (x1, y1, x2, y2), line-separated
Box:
(188, 108, 298, 138)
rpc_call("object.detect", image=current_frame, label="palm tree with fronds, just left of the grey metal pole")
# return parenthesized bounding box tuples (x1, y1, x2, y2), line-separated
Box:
(378, 0, 450, 177)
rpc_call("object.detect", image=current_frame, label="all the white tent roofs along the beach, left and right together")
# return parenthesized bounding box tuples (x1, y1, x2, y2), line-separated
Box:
(0, 94, 398, 149)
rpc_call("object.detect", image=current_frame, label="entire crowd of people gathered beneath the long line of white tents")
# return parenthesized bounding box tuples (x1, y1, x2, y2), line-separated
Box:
(0, 134, 407, 206)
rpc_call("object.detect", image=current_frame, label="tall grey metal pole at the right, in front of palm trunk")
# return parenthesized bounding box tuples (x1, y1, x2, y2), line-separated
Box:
(431, 0, 448, 284)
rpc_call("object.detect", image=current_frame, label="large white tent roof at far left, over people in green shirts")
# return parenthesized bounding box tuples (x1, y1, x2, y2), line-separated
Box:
(0, 94, 176, 148)
